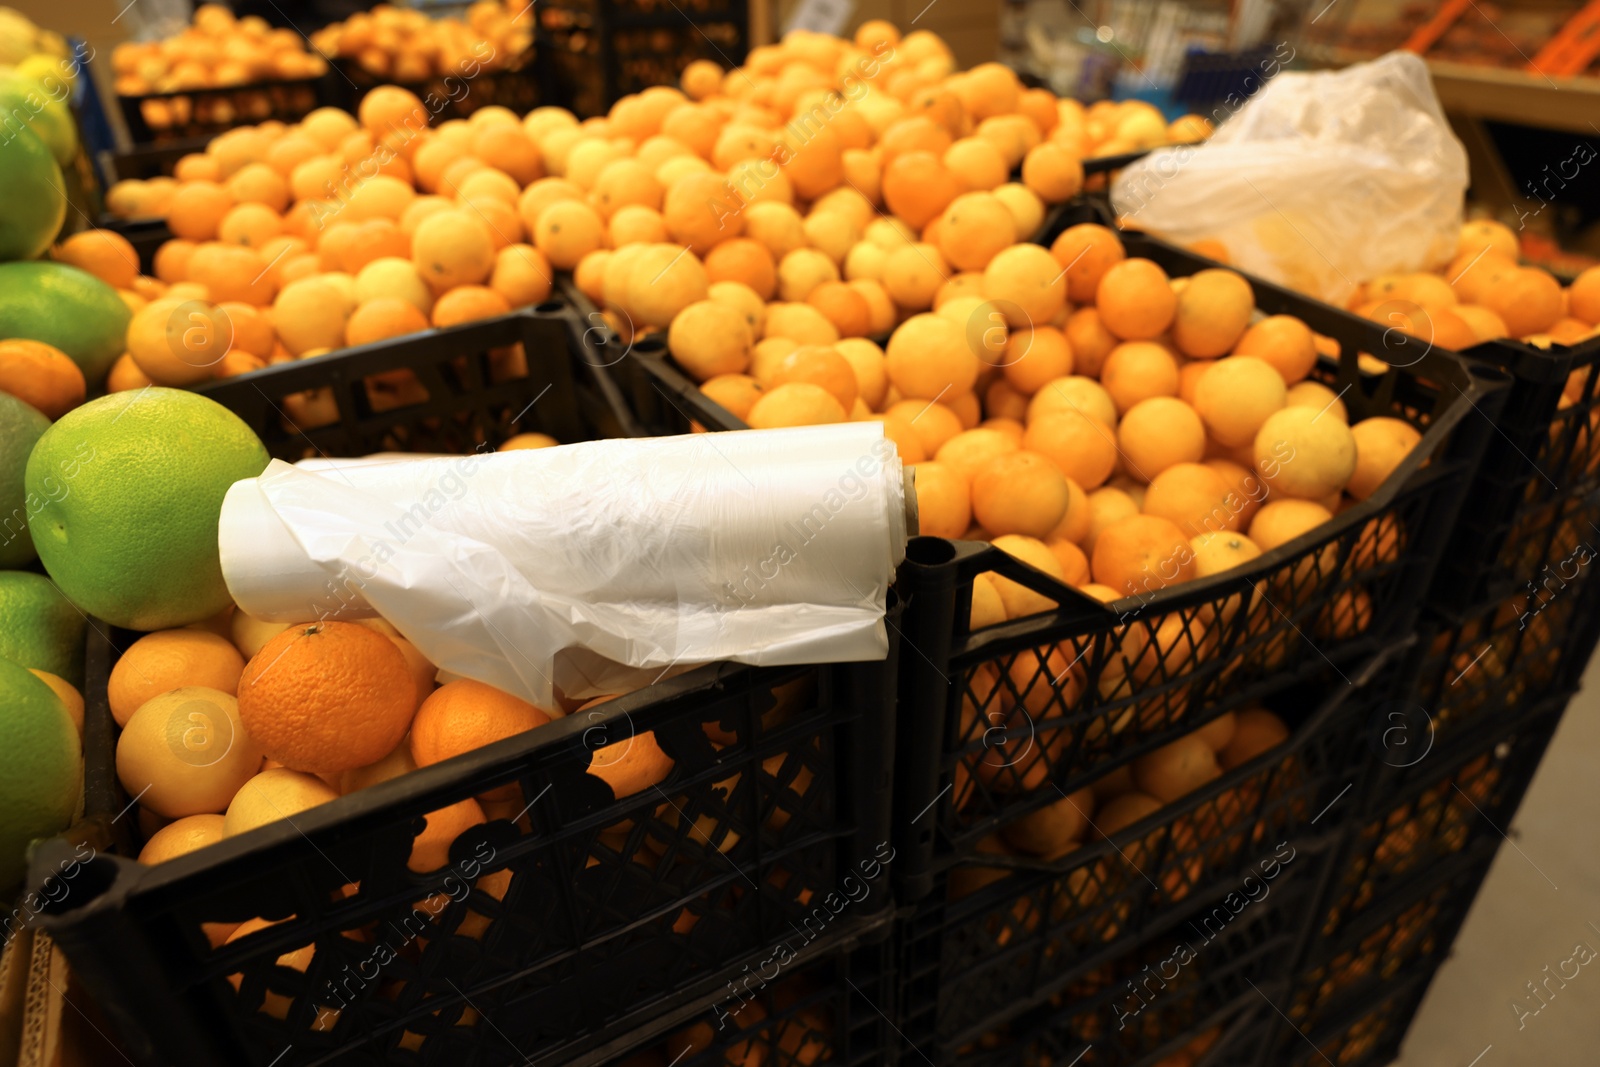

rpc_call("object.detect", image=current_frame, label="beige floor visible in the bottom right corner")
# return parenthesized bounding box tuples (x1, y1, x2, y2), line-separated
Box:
(1395, 657, 1600, 1067)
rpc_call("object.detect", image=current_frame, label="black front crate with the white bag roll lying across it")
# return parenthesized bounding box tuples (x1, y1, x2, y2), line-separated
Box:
(29, 300, 898, 1065)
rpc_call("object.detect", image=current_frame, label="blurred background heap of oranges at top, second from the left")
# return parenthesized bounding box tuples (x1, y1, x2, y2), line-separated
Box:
(310, 0, 533, 82)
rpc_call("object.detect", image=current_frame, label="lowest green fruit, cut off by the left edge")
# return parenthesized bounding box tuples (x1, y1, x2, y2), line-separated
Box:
(0, 659, 83, 891)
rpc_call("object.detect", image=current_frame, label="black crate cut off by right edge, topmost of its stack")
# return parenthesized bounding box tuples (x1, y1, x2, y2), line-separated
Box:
(1432, 339, 1600, 613)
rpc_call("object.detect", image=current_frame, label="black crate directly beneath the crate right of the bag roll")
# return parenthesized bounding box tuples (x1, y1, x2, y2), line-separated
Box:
(899, 656, 1400, 1061)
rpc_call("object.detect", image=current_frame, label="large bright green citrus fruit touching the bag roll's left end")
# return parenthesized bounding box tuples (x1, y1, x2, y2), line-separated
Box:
(27, 387, 269, 630)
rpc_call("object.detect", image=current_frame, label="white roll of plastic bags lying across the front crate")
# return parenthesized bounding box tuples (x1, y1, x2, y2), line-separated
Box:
(219, 422, 907, 707)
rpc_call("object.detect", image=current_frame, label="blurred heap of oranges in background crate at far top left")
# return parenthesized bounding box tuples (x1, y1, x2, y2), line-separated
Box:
(110, 3, 328, 96)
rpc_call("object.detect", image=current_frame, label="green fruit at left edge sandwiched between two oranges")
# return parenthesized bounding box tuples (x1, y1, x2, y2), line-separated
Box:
(0, 262, 133, 383)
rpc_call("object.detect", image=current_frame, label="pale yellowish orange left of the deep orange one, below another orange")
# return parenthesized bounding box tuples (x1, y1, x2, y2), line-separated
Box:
(117, 684, 261, 819)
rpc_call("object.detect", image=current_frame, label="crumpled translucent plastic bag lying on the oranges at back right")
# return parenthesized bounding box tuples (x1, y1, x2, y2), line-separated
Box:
(1112, 53, 1467, 306)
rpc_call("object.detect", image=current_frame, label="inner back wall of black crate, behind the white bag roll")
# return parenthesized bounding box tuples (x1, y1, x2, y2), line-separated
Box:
(195, 301, 640, 461)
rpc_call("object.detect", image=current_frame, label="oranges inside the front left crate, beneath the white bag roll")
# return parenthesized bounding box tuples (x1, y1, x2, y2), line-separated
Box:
(107, 608, 672, 895)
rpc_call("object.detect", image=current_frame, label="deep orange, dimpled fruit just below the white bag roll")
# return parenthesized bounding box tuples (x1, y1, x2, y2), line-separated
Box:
(238, 622, 416, 774)
